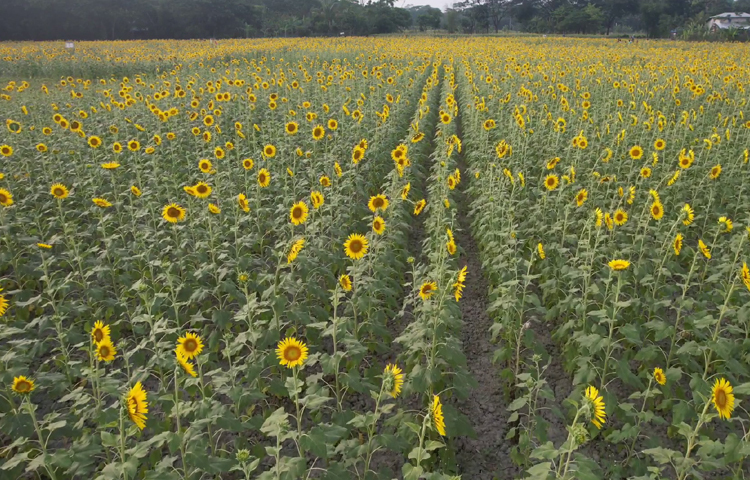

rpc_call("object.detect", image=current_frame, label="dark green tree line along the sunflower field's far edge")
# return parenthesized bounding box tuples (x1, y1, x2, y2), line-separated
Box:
(0, 0, 750, 41)
